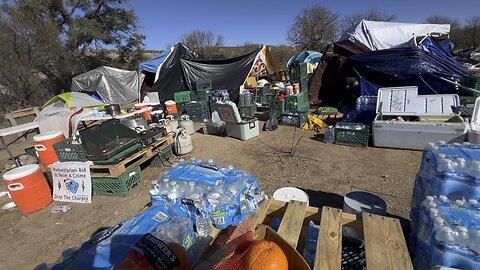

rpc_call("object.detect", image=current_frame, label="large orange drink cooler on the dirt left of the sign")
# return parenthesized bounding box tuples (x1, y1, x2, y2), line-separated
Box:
(3, 164, 52, 214)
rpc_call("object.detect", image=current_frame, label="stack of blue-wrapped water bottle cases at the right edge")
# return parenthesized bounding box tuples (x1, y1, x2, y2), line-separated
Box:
(410, 142, 480, 269)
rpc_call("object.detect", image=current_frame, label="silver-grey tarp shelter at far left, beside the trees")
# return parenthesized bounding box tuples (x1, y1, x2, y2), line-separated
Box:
(71, 66, 145, 105)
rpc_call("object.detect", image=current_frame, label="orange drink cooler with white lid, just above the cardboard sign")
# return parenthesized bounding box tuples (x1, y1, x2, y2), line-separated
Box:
(33, 131, 65, 172)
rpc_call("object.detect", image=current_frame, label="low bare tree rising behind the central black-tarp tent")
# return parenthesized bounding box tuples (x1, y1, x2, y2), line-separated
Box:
(180, 30, 225, 54)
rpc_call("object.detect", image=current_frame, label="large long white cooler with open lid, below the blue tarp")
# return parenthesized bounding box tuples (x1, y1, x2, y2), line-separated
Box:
(372, 86, 468, 150)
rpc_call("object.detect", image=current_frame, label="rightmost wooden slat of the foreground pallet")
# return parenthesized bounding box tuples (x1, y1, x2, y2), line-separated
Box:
(362, 213, 413, 269)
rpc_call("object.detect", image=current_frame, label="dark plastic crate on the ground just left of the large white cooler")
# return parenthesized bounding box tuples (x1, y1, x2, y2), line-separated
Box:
(335, 122, 369, 147)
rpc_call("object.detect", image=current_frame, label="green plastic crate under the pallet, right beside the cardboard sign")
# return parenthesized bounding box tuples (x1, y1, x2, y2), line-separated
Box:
(92, 166, 142, 197)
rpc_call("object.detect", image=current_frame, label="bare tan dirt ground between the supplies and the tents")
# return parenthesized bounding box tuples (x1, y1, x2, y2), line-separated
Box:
(0, 121, 421, 269)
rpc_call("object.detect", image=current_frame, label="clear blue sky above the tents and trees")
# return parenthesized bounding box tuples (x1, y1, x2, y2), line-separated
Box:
(127, 0, 480, 50)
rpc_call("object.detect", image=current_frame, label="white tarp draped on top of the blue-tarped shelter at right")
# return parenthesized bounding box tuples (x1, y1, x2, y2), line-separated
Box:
(339, 20, 450, 51)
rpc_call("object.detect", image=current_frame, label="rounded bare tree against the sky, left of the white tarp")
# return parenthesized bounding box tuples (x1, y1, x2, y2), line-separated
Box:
(287, 5, 338, 51)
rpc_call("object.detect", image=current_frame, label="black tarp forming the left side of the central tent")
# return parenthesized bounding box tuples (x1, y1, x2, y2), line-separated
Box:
(150, 43, 197, 101)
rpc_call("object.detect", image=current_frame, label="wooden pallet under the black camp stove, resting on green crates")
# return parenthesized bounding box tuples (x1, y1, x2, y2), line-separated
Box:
(90, 135, 173, 178)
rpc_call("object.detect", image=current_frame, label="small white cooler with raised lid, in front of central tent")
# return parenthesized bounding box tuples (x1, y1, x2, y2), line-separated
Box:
(217, 101, 260, 141)
